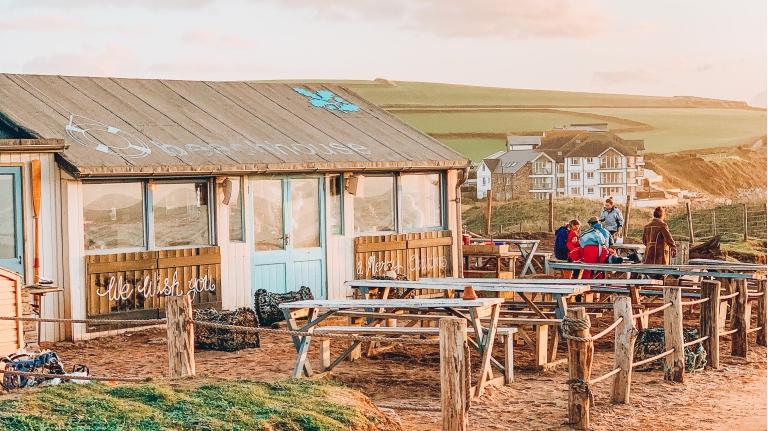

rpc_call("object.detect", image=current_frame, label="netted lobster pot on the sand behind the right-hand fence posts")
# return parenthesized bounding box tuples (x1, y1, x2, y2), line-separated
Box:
(634, 328, 707, 372)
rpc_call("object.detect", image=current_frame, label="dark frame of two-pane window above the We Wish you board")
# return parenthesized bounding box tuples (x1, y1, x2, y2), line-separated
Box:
(80, 177, 214, 256)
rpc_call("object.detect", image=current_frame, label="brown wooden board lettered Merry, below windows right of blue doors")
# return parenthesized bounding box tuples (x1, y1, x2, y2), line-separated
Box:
(355, 230, 453, 280)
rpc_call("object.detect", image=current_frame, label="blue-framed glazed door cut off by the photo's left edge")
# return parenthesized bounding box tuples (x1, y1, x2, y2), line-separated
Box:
(0, 166, 24, 275)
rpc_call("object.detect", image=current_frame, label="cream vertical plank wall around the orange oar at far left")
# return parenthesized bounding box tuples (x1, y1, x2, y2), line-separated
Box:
(0, 153, 67, 341)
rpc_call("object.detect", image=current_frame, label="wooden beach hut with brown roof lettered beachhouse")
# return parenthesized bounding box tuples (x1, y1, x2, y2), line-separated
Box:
(0, 74, 469, 340)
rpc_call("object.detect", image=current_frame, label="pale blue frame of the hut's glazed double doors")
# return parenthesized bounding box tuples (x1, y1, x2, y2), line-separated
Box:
(249, 174, 328, 297)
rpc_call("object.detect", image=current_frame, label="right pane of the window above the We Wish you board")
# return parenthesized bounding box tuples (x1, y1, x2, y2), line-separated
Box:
(151, 182, 210, 247)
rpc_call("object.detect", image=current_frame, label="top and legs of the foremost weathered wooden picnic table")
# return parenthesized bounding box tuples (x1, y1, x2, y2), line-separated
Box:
(279, 298, 504, 395)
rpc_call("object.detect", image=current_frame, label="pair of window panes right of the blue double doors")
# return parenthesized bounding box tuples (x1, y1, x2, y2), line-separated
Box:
(354, 173, 444, 233)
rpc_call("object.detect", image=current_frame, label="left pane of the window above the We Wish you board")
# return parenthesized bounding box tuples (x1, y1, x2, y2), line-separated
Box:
(83, 182, 145, 250)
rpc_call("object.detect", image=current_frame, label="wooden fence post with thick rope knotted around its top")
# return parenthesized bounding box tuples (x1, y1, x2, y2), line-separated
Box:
(567, 307, 595, 430)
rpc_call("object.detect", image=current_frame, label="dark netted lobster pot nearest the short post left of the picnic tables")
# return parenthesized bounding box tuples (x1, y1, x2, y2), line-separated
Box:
(194, 308, 260, 352)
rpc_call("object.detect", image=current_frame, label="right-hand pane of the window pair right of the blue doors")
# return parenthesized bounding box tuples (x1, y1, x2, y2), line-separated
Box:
(400, 174, 443, 230)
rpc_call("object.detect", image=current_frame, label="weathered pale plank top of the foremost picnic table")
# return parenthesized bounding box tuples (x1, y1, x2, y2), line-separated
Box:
(279, 298, 504, 310)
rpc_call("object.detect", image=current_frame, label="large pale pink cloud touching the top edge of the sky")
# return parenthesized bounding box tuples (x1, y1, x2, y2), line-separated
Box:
(273, 0, 608, 39)
